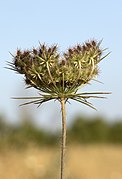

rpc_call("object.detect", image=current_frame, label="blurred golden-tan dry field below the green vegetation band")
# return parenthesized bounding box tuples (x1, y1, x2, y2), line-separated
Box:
(0, 145, 122, 179)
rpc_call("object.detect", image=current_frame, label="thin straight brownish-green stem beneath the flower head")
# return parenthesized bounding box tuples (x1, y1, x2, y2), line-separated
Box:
(60, 98, 66, 179)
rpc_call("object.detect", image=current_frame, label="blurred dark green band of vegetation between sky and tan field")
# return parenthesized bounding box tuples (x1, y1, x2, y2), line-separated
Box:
(0, 116, 122, 149)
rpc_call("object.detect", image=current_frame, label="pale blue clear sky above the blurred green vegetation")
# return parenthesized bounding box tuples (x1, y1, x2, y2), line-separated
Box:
(0, 0, 122, 129)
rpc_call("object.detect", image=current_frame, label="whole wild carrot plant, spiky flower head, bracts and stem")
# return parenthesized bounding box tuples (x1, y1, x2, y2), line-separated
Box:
(8, 40, 108, 179)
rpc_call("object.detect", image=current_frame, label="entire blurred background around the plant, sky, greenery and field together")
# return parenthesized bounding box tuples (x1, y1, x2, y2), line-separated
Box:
(0, 0, 122, 179)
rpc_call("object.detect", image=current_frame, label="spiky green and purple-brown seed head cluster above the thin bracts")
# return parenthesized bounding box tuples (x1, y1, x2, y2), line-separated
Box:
(9, 40, 109, 108)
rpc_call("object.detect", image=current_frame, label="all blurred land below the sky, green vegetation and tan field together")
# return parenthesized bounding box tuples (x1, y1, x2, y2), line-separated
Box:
(0, 116, 122, 179)
